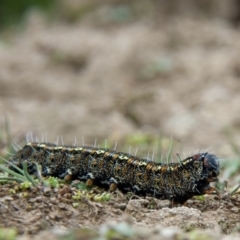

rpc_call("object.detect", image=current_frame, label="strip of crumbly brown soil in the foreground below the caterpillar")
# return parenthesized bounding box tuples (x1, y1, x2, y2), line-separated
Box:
(0, 181, 240, 239)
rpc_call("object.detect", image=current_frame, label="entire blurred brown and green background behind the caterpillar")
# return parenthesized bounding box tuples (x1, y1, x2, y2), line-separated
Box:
(0, 0, 240, 161)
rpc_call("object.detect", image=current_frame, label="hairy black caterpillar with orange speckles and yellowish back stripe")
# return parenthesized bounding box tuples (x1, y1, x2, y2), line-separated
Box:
(10, 142, 220, 205)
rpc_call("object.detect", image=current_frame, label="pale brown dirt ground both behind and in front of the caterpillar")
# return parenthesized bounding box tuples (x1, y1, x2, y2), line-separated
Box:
(0, 0, 240, 239)
